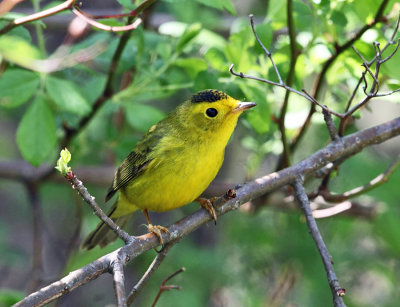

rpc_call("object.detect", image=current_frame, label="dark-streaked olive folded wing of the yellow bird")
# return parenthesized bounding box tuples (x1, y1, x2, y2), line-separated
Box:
(105, 127, 162, 201)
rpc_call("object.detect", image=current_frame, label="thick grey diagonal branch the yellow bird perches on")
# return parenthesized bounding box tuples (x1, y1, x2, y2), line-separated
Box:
(15, 117, 400, 307)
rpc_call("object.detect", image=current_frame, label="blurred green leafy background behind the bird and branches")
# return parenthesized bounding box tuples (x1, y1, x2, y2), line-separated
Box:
(0, 0, 400, 306)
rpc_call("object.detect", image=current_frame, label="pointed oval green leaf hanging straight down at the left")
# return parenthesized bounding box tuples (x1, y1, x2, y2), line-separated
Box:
(17, 95, 57, 166)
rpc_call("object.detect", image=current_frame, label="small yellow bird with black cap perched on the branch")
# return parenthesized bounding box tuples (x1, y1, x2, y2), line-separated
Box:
(82, 90, 256, 249)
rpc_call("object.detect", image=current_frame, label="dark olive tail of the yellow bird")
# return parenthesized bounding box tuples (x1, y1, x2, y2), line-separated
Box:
(81, 200, 131, 250)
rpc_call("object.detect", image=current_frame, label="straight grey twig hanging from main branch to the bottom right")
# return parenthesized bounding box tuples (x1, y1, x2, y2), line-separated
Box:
(292, 178, 346, 307)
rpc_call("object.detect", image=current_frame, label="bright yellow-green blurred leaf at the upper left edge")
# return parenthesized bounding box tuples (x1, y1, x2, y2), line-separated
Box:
(0, 35, 41, 68)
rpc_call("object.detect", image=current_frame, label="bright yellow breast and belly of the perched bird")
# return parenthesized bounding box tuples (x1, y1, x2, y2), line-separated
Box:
(121, 132, 226, 214)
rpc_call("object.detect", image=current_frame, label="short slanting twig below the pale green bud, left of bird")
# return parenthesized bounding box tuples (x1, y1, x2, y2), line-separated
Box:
(66, 172, 135, 244)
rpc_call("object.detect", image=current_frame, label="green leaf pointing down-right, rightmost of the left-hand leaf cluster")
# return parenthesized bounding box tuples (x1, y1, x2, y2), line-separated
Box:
(45, 76, 90, 115)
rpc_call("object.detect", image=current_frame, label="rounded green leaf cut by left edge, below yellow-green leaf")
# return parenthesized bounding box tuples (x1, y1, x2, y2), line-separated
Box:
(0, 69, 40, 108)
